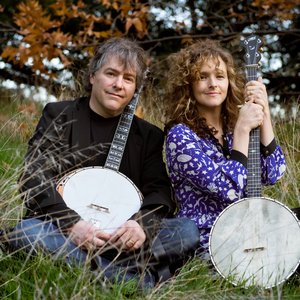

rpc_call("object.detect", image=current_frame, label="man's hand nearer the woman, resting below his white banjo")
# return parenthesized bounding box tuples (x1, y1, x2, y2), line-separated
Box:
(110, 220, 146, 250)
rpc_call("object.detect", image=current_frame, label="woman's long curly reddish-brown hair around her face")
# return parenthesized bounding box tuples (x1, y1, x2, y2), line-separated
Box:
(163, 39, 245, 137)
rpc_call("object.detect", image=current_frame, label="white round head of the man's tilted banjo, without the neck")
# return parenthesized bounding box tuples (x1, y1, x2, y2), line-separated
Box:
(57, 167, 143, 233)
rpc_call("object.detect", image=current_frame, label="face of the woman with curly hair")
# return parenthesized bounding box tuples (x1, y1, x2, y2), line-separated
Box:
(192, 57, 229, 110)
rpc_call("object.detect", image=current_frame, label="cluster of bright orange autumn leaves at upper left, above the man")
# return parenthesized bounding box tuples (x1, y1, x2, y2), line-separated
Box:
(2, 0, 146, 72)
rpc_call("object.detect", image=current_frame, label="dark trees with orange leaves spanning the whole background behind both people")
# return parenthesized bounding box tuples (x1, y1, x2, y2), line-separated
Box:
(0, 0, 300, 101)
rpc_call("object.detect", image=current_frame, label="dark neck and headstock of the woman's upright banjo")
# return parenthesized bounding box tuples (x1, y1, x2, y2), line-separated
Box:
(242, 35, 262, 198)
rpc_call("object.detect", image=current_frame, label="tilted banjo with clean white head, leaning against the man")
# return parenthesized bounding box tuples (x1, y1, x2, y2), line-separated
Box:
(57, 79, 143, 233)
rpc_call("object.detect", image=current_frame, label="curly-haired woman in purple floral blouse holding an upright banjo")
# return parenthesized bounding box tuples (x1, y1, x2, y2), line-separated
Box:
(165, 40, 286, 257)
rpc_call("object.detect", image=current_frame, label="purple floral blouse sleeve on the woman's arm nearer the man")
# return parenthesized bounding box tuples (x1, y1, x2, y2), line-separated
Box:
(166, 125, 247, 203)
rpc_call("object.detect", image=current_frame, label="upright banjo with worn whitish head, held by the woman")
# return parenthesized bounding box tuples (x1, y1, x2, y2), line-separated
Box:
(209, 35, 300, 288)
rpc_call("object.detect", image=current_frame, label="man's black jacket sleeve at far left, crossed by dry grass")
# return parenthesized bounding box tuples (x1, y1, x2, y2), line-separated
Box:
(19, 103, 80, 229)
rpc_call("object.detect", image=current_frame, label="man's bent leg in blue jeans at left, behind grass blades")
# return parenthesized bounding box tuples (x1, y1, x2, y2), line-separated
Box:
(8, 218, 154, 287)
